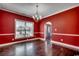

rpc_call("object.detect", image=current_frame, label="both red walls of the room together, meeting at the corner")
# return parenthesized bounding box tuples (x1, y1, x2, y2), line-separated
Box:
(0, 7, 79, 46)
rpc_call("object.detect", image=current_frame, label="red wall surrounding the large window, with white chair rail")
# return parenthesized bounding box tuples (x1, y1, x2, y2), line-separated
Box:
(0, 10, 38, 44)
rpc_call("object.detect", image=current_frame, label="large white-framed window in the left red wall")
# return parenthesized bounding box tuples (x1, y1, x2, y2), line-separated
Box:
(15, 19, 34, 39)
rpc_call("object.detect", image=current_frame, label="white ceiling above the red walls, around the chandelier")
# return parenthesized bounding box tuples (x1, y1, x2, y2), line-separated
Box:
(0, 3, 79, 18)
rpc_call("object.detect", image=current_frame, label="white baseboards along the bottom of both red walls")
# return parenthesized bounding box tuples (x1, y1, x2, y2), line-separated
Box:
(0, 38, 79, 51)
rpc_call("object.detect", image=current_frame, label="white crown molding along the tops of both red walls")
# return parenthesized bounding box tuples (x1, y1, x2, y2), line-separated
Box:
(0, 4, 79, 19)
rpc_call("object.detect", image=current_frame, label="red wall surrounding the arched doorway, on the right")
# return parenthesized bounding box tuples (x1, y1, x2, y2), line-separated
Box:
(39, 7, 79, 46)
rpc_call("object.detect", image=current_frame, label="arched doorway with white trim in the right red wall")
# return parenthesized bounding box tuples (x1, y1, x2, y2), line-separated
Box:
(44, 22, 52, 43)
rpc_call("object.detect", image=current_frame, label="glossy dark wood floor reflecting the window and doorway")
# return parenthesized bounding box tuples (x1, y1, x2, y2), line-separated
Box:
(0, 40, 79, 56)
